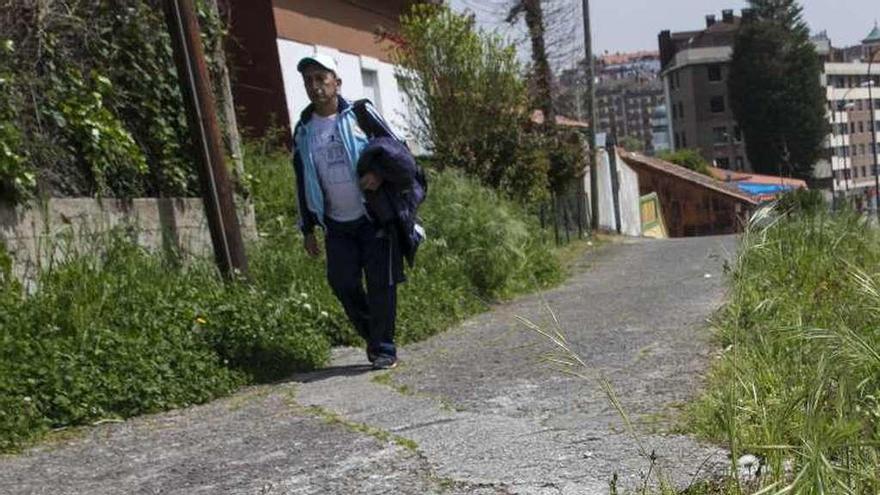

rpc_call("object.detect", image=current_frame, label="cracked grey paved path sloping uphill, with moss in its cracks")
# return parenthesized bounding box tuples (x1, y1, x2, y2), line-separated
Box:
(0, 237, 735, 495)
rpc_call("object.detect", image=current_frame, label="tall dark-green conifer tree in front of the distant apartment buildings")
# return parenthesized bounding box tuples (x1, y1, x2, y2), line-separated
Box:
(728, 0, 828, 179)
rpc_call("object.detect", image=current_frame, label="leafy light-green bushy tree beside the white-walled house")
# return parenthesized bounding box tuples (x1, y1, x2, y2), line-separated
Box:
(392, 4, 549, 202)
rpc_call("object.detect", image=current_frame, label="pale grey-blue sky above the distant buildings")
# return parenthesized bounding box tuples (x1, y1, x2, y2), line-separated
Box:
(449, 0, 880, 60)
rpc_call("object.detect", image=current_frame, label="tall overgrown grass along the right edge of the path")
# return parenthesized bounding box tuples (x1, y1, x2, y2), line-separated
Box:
(689, 201, 880, 494)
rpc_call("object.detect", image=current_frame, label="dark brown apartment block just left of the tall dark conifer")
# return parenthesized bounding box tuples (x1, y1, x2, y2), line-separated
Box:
(659, 9, 752, 171)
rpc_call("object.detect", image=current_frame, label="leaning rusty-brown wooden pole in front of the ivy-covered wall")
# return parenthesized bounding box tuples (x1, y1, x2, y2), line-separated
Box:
(163, 0, 247, 276)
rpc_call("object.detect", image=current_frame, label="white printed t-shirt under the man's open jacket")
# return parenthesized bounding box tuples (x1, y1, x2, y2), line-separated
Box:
(309, 114, 365, 222)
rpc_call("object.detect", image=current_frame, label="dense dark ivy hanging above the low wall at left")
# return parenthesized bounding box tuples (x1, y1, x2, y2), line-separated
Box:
(0, 0, 225, 203)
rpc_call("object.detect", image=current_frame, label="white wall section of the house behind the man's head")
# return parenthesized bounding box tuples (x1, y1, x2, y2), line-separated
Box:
(278, 39, 411, 140)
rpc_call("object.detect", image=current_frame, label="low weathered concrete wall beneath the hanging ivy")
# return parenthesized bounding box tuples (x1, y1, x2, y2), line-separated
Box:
(0, 198, 256, 279)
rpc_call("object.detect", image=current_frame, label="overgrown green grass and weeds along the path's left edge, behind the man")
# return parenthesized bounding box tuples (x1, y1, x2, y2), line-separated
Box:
(0, 141, 562, 451)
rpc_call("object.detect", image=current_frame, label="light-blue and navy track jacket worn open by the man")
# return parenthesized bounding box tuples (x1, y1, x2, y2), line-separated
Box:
(293, 96, 399, 234)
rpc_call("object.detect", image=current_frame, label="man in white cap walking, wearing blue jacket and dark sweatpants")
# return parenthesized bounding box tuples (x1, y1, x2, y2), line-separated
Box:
(293, 54, 404, 369)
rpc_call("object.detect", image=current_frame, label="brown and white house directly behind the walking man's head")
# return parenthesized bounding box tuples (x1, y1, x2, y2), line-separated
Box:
(229, 0, 419, 143)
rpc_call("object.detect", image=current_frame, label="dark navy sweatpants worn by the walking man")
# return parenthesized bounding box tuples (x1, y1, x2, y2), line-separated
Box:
(325, 217, 403, 356)
